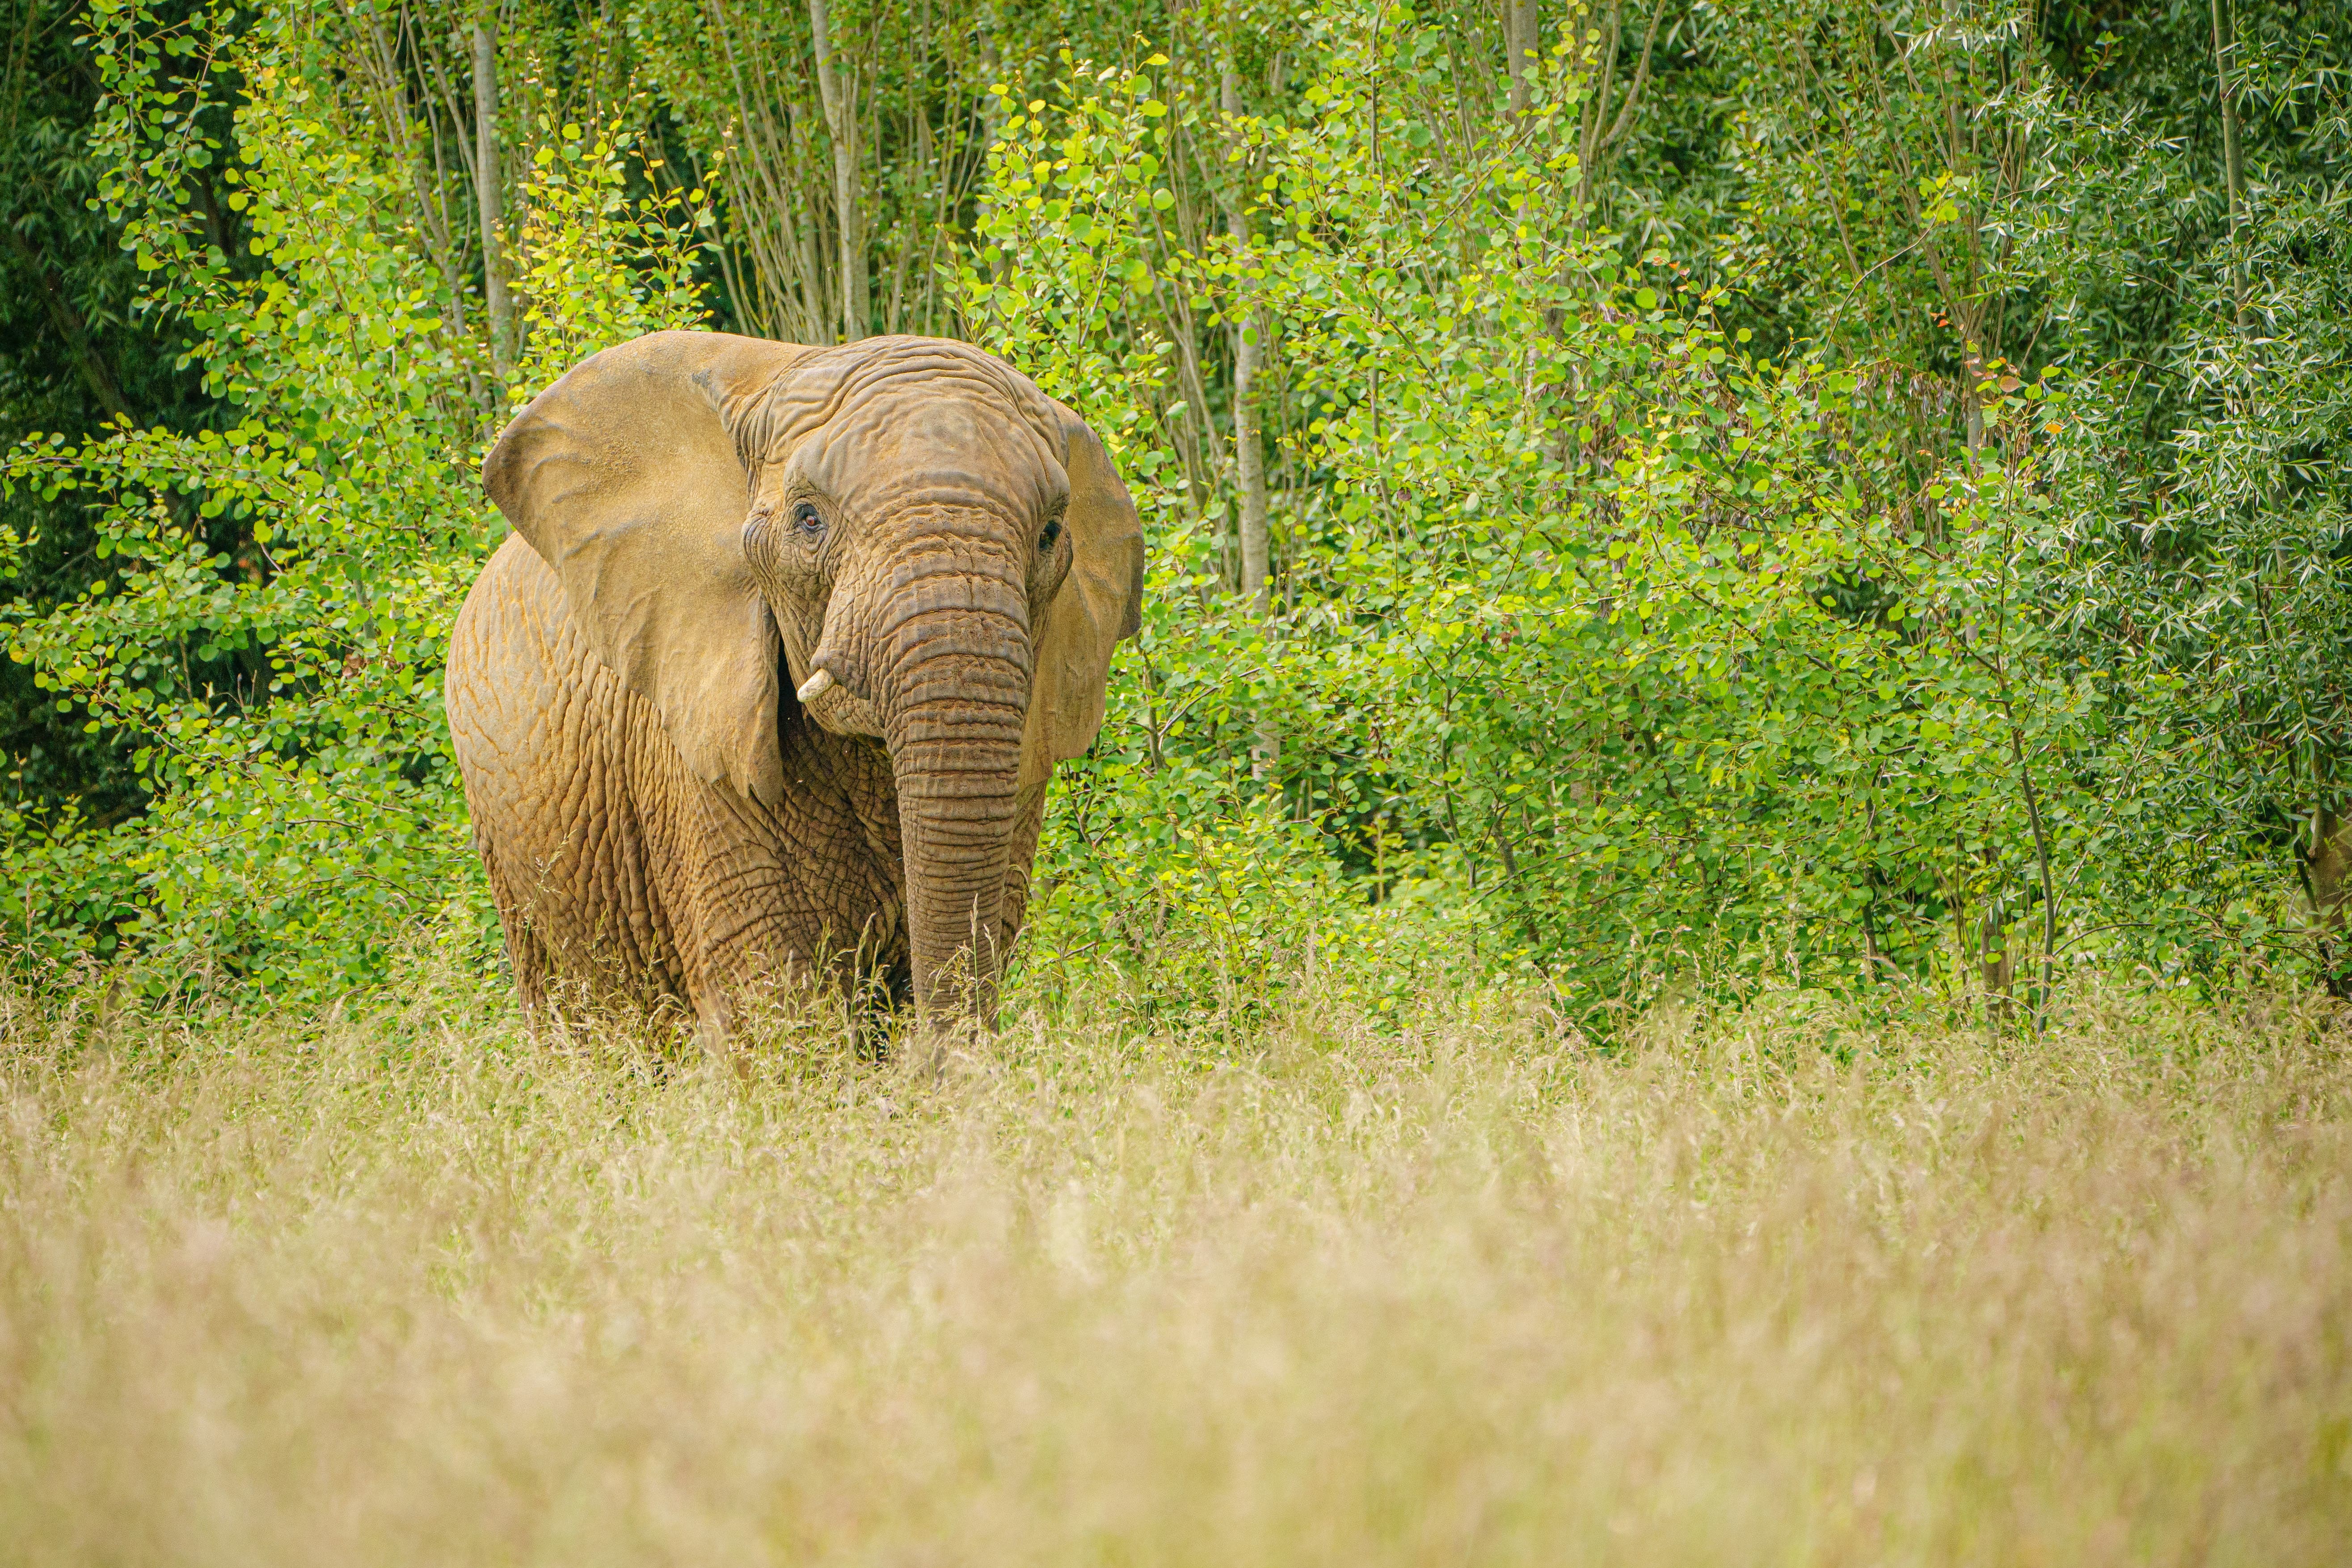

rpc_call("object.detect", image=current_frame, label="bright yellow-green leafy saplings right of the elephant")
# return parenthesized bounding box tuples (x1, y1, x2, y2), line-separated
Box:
(962, 21, 2183, 1029)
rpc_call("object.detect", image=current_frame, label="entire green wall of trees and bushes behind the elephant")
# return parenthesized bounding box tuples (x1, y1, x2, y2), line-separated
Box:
(0, 0, 2352, 1030)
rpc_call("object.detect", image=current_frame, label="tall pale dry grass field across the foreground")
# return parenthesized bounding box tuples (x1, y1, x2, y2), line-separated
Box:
(0, 982, 2352, 1566)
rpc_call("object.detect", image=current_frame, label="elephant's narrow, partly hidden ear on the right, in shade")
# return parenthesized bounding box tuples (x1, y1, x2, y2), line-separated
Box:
(1021, 405, 1143, 785)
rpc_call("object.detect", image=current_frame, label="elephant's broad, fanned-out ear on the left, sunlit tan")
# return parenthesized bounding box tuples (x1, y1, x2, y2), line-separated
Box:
(482, 332, 809, 804)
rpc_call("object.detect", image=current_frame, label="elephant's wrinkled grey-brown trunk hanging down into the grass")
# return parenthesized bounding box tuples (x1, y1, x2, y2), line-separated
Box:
(887, 567, 1030, 1030)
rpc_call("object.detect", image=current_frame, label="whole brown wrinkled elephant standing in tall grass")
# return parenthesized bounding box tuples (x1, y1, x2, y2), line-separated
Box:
(445, 332, 1143, 1039)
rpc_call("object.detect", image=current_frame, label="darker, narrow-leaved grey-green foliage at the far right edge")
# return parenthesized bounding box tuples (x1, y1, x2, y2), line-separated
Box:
(2063, 17, 2352, 987)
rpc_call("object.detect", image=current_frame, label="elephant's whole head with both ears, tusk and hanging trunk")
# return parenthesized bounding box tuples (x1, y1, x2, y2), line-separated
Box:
(482, 332, 1143, 1020)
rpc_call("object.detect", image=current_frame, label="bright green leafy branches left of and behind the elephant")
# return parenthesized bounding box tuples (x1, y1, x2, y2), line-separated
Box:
(7, 7, 696, 990)
